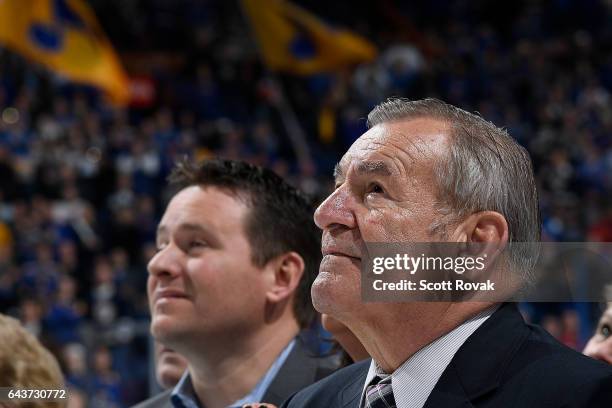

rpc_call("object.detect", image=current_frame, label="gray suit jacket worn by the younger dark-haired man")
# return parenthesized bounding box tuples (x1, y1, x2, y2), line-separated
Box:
(133, 337, 338, 408)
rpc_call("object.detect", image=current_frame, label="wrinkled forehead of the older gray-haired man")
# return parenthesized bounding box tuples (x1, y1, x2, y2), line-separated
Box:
(336, 118, 449, 175)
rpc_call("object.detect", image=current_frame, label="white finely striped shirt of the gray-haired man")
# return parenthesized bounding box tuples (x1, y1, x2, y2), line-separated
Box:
(360, 306, 498, 408)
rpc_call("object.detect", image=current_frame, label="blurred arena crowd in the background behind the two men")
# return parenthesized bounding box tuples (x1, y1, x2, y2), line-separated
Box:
(0, 0, 612, 407)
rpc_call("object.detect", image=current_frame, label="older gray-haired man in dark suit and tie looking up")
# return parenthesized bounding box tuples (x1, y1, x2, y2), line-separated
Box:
(285, 99, 612, 408)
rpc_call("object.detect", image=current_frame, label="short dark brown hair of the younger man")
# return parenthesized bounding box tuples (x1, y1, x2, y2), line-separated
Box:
(168, 159, 321, 328)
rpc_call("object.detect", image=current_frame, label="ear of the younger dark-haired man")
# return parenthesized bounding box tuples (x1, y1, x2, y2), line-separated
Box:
(265, 251, 304, 303)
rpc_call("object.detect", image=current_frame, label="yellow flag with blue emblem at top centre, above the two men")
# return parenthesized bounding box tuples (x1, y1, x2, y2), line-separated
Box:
(242, 0, 376, 75)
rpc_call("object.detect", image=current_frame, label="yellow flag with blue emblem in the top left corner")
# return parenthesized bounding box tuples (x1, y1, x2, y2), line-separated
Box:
(0, 0, 129, 104)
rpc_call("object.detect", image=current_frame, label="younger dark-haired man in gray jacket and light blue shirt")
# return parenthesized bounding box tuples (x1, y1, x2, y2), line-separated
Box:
(134, 160, 332, 408)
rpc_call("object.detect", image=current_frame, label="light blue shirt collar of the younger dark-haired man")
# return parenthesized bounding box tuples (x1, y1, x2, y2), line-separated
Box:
(170, 339, 296, 408)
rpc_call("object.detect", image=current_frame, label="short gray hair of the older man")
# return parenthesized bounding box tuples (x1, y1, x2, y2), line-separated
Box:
(368, 98, 540, 282)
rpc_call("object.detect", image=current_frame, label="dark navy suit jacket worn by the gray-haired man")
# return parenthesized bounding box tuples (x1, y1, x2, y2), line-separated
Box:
(283, 303, 612, 408)
